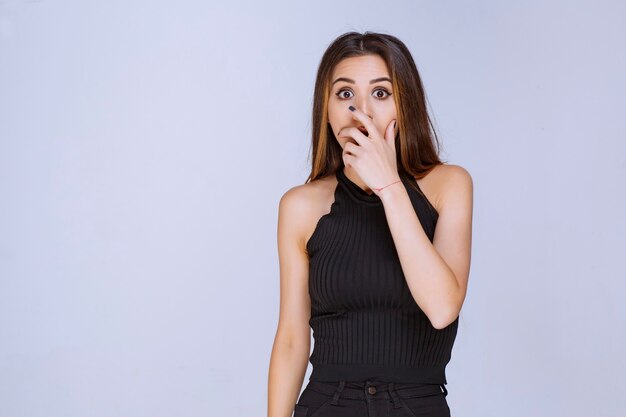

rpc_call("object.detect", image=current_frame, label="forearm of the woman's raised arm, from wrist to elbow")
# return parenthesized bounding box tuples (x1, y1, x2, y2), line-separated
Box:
(380, 184, 460, 328)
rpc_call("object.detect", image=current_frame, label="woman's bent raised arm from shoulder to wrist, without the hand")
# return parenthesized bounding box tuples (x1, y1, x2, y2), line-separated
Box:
(380, 165, 473, 329)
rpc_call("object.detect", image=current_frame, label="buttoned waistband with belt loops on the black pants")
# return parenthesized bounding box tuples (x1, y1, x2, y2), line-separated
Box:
(306, 380, 448, 408)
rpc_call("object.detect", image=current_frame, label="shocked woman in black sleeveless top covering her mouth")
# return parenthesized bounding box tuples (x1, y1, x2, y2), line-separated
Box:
(268, 32, 473, 417)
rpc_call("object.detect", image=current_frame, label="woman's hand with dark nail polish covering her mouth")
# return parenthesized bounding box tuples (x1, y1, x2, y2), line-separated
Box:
(339, 106, 400, 195)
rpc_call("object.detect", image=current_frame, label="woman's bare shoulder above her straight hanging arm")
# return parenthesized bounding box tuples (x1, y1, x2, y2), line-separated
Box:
(279, 171, 337, 248)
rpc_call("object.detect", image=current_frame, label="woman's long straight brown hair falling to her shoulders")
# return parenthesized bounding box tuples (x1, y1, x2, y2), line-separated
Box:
(305, 32, 443, 195)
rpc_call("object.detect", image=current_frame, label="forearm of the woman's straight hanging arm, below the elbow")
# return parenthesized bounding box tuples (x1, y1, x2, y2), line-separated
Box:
(267, 339, 310, 417)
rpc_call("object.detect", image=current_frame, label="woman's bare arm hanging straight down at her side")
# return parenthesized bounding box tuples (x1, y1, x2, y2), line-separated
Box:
(267, 186, 311, 417)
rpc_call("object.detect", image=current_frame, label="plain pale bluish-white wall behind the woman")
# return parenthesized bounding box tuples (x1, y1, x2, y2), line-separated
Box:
(0, 0, 626, 417)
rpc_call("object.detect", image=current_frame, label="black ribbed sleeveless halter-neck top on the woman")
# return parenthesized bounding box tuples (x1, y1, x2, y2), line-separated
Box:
(306, 166, 458, 384)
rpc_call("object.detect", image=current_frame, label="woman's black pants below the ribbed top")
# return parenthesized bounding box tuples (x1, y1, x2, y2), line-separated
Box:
(294, 381, 450, 417)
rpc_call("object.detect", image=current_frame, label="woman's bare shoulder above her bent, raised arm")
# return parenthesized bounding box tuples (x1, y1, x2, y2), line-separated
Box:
(417, 164, 473, 212)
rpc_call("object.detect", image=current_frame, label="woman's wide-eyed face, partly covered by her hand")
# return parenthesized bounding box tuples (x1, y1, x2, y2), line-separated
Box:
(328, 55, 397, 148)
